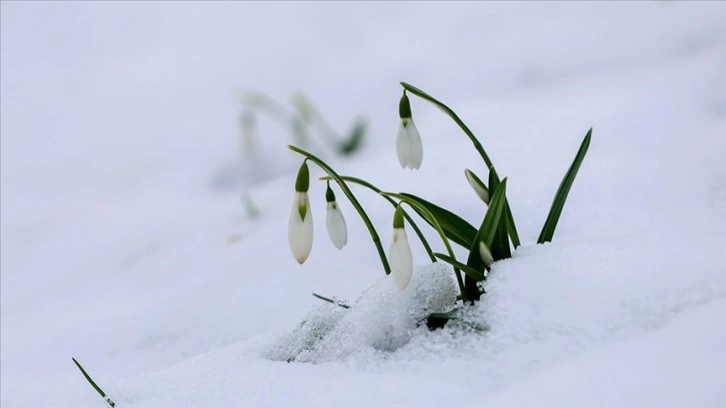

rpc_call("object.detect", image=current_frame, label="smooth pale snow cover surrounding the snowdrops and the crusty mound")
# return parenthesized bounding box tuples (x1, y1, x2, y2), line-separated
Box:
(0, 2, 726, 407)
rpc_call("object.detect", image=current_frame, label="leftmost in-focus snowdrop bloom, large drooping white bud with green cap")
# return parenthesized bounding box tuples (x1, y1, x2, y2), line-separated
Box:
(287, 161, 313, 264)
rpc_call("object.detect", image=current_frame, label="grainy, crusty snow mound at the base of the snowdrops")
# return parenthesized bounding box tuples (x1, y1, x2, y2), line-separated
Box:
(266, 263, 457, 363)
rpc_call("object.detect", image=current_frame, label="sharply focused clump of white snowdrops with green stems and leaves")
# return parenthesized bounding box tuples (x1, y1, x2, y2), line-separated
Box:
(289, 82, 592, 323)
